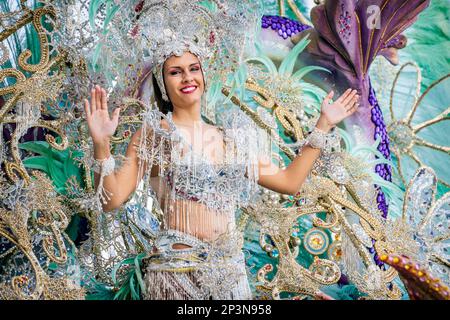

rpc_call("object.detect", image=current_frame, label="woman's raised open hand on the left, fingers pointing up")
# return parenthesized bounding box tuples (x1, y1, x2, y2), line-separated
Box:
(84, 85, 120, 144)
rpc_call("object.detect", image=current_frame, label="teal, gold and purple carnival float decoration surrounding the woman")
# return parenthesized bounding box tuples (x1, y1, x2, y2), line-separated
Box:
(0, 0, 450, 300)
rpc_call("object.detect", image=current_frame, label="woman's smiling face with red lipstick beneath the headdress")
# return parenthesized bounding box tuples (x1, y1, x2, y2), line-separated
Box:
(163, 52, 205, 107)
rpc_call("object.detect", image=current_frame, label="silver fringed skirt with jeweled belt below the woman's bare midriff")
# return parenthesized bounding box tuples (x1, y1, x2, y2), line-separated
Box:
(144, 230, 252, 300)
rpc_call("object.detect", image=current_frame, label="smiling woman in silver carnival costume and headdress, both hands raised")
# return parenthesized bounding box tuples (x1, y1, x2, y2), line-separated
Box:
(84, 1, 359, 299)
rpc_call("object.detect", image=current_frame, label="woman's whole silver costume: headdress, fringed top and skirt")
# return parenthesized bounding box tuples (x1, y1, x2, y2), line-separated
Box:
(82, 0, 271, 299)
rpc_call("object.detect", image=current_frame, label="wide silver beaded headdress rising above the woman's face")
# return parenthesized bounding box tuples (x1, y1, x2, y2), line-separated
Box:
(103, 0, 259, 107)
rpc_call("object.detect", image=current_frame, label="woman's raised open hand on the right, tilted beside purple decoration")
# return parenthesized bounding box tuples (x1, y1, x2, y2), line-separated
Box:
(317, 88, 360, 132)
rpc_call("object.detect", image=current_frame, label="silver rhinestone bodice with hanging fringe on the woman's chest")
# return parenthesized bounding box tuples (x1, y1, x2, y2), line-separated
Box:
(139, 112, 259, 213)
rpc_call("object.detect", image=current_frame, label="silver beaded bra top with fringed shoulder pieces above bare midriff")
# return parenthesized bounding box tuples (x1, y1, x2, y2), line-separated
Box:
(140, 110, 268, 212)
